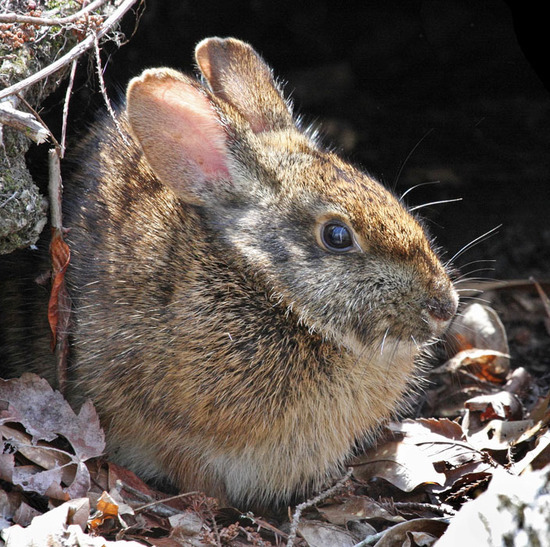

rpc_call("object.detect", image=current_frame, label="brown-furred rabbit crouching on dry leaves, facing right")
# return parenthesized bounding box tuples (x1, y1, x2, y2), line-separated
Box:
(4, 37, 458, 510)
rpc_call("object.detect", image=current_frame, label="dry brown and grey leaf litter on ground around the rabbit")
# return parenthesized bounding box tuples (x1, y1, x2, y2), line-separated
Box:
(0, 282, 550, 547)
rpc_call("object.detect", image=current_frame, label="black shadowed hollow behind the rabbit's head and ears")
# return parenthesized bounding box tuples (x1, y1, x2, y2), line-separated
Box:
(49, 0, 550, 279)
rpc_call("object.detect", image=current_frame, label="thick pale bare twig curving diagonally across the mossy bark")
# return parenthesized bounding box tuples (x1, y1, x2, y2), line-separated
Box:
(0, 0, 138, 99)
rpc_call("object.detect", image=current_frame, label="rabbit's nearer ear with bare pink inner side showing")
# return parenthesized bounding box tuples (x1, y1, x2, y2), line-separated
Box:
(127, 69, 230, 203)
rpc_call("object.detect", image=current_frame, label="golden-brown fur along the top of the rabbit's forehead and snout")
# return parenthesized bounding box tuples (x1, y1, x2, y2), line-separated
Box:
(248, 135, 440, 266)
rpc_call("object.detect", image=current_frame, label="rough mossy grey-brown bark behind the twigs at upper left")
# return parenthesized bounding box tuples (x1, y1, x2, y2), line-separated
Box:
(0, 0, 91, 254)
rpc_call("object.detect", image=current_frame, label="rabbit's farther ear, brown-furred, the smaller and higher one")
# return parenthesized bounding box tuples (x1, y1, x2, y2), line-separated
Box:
(195, 38, 294, 133)
